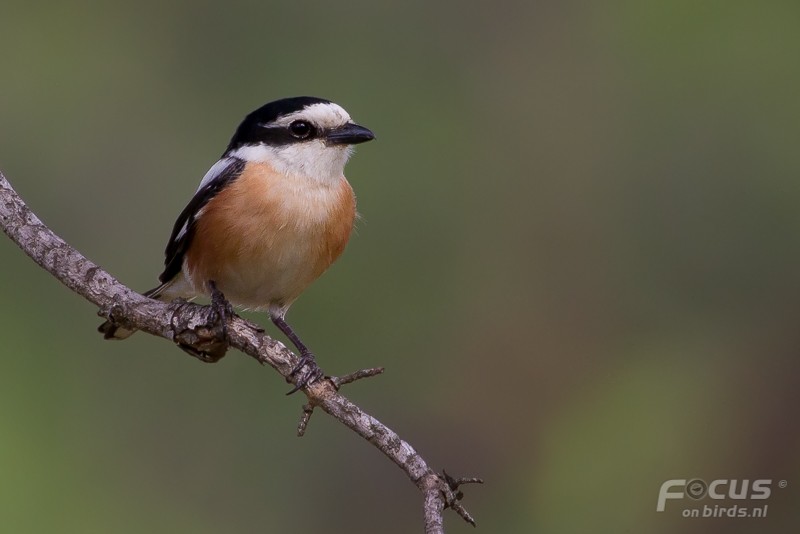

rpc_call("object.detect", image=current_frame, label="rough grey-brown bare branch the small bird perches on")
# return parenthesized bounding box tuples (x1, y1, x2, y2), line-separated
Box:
(0, 172, 477, 534)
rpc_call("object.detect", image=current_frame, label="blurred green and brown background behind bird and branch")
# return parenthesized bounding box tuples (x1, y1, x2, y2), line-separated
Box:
(0, 0, 800, 534)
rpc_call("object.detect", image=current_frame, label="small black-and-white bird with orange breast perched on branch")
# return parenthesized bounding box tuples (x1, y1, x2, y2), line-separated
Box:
(98, 96, 375, 392)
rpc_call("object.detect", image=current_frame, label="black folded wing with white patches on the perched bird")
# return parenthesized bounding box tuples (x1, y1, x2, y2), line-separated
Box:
(158, 158, 245, 283)
